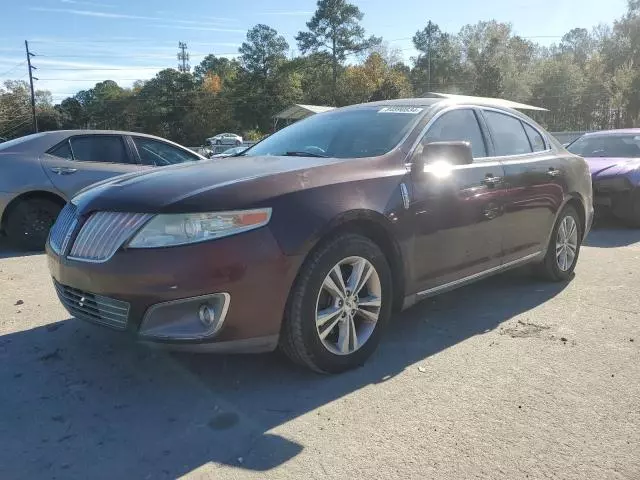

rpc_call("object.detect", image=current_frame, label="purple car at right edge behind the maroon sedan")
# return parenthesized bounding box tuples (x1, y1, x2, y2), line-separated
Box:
(567, 129, 640, 228)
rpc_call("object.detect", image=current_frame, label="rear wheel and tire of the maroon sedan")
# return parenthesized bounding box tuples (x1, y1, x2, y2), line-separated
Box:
(536, 205, 583, 282)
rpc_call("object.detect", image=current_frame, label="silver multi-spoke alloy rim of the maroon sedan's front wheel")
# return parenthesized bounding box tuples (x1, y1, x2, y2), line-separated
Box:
(315, 257, 382, 355)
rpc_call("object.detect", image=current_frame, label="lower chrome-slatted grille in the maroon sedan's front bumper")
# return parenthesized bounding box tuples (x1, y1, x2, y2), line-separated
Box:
(53, 280, 129, 330)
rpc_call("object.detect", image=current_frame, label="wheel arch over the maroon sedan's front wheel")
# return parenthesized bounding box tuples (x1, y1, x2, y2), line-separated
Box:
(300, 210, 406, 311)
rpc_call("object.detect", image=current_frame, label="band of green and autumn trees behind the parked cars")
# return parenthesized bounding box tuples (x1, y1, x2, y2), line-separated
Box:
(0, 0, 640, 142)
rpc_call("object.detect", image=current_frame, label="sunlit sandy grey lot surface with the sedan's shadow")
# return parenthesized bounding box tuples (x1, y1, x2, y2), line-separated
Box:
(0, 226, 640, 480)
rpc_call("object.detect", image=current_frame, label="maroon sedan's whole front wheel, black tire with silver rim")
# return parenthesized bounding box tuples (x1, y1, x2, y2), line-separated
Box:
(280, 234, 393, 373)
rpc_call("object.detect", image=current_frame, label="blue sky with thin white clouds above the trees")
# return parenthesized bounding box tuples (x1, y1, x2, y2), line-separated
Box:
(0, 0, 626, 101)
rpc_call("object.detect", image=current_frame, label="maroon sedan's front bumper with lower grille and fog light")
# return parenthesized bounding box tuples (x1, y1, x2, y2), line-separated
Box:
(47, 228, 298, 352)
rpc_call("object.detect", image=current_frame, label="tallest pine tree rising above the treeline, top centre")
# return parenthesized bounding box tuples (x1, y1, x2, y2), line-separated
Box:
(296, 0, 381, 104)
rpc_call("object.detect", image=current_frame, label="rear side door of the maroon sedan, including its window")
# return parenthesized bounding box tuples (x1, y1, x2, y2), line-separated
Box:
(482, 109, 565, 263)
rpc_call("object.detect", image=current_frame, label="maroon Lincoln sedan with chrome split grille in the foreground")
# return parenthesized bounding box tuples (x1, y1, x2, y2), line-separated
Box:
(47, 96, 593, 372)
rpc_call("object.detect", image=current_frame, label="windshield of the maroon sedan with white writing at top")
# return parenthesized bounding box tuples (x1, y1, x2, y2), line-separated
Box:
(244, 107, 424, 158)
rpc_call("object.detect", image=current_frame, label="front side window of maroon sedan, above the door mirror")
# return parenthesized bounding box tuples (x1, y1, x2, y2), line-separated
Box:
(421, 109, 487, 158)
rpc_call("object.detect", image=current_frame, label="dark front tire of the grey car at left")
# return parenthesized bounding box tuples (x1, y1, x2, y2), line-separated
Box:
(5, 198, 62, 251)
